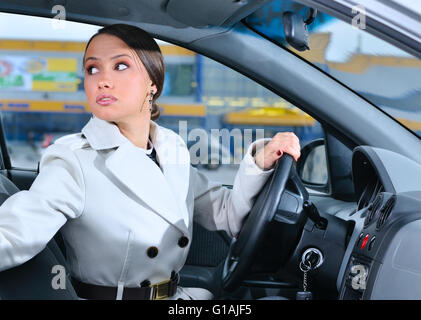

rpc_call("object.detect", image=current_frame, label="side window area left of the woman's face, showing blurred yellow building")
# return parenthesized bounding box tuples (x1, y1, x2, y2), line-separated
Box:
(0, 13, 99, 170)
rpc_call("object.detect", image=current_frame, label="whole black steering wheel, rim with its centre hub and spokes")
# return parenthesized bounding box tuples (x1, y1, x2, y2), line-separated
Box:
(222, 153, 308, 291)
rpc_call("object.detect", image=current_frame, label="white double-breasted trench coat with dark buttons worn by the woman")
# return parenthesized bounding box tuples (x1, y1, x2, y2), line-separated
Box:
(0, 116, 273, 298)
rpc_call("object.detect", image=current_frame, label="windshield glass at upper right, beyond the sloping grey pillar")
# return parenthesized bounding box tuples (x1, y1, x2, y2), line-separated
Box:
(245, 0, 421, 137)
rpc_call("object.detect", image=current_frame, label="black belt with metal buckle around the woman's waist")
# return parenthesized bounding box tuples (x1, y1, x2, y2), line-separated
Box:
(72, 273, 178, 300)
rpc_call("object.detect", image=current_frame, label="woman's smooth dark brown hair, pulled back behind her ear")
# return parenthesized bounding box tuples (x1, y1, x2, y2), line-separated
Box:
(83, 23, 165, 120)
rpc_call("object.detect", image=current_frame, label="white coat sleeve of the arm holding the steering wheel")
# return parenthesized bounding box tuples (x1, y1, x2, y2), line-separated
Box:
(192, 138, 273, 237)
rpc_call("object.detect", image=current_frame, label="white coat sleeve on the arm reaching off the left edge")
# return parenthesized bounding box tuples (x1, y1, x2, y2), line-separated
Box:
(0, 144, 85, 271)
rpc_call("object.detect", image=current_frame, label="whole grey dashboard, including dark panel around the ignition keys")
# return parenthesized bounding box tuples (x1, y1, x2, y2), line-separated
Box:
(282, 146, 421, 300)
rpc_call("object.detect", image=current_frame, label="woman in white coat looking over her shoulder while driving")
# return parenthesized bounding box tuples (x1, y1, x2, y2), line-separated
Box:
(0, 24, 300, 299)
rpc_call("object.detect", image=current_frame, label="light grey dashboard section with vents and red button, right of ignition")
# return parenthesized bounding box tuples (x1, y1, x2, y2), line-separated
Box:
(337, 146, 421, 300)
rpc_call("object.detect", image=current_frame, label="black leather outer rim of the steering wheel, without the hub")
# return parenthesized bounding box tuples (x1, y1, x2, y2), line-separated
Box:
(222, 153, 294, 291)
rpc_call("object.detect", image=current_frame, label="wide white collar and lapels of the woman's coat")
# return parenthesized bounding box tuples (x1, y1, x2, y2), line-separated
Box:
(82, 117, 190, 234)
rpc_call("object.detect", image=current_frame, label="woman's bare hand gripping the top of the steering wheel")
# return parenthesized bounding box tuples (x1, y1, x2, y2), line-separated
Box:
(254, 132, 301, 170)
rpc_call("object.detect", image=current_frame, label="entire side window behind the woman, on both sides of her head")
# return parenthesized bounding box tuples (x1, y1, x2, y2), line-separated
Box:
(0, 14, 325, 188)
